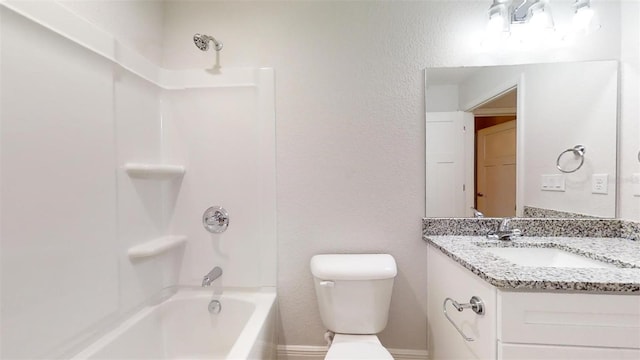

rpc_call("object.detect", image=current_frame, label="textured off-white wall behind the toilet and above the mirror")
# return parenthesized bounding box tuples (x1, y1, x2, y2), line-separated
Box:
(163, 1, 637, 349)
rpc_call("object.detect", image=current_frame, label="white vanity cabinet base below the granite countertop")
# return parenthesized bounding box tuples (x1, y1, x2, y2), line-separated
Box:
(427, 245, 640, 360)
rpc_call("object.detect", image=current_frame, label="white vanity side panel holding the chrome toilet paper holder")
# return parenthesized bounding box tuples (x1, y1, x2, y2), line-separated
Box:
(427, 245, 496, 360)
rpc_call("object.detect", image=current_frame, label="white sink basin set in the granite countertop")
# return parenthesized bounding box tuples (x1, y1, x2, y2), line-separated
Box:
(484, 247, 617, 268)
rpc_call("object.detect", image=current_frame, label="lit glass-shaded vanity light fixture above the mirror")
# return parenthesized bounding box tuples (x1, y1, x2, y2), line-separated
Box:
(487, 0, 594, 35)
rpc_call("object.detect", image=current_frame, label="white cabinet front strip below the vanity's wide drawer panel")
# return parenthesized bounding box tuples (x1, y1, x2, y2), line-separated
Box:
(498, 344, 640, 360)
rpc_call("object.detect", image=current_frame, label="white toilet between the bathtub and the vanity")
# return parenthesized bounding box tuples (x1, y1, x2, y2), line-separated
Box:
(311, 254, 397, 360)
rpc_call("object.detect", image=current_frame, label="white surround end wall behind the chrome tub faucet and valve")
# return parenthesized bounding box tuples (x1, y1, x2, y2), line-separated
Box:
(162, 69, 276, 288)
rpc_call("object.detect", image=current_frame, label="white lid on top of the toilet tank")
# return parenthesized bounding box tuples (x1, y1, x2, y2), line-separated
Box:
(311, 254, 398, 280)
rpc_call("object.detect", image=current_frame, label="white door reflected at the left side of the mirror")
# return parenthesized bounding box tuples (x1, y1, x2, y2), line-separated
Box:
(425, 111, 474, 217)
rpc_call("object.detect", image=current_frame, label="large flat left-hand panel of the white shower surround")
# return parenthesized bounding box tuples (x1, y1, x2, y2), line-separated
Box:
(0, 10, 118, 358)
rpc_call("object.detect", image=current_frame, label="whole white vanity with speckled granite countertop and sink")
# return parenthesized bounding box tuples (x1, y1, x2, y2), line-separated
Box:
(424, 224, 640, 359)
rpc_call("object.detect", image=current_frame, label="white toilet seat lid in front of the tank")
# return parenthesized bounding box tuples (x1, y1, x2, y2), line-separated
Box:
(325, 334, 393, 360)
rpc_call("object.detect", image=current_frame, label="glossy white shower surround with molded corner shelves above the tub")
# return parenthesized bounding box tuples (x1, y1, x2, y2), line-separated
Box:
(0, 1, 276, 358)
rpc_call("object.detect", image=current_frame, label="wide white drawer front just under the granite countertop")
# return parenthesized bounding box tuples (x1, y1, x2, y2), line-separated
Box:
(498, 291, 640, 348)
